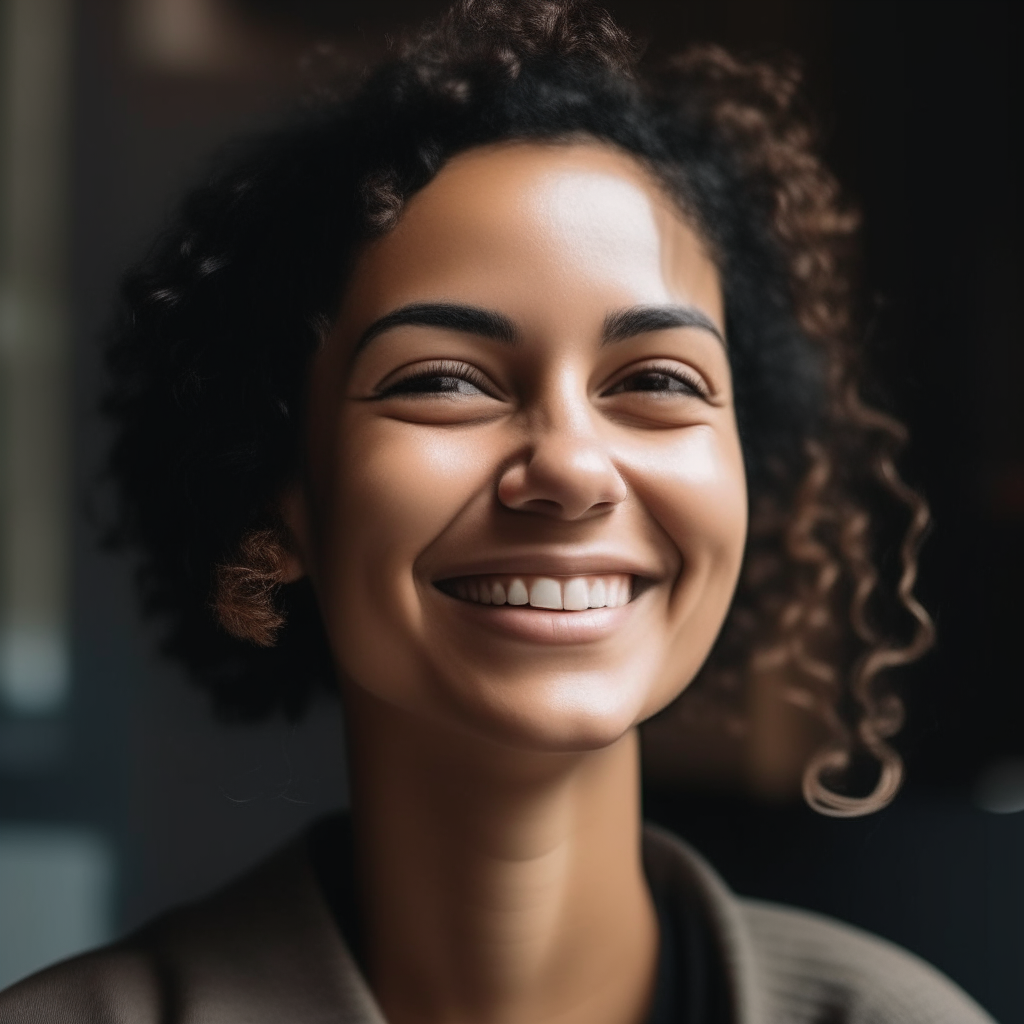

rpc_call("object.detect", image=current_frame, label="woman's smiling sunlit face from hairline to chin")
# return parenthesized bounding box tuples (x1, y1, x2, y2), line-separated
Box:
(293, 143, 746, 751)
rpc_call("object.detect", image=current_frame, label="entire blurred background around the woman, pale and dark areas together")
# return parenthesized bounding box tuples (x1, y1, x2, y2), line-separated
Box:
(0, 0, 1024, 1021)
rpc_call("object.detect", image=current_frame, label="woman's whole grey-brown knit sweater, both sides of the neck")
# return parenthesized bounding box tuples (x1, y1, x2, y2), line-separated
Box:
(0, 826, 992, 1024)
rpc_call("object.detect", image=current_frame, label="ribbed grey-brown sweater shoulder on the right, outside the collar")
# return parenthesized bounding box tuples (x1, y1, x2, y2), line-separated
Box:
(738, 899, 992, 1024)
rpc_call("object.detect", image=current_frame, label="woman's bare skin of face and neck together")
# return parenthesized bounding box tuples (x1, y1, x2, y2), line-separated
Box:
(285, 141, 746, 1024)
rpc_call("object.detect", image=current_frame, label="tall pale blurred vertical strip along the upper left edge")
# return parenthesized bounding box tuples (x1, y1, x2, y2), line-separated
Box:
(0, 0, 71, 716)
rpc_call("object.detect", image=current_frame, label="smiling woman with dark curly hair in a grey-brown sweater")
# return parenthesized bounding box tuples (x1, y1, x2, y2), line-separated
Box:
(0, 0, 987, 1024)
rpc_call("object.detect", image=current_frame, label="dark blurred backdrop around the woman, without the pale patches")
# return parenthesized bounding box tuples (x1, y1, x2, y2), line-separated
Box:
(0, 0, 1024, 1022)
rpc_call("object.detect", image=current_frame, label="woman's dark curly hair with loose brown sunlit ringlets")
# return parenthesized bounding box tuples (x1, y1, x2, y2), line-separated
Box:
(104, 0, 932, 815)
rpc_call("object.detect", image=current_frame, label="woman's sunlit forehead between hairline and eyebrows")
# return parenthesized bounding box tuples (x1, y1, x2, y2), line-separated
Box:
(349, 142, 723, 326)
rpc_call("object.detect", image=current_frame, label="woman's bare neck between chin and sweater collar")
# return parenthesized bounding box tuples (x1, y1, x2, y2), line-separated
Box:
(346, 679, 657, 1024)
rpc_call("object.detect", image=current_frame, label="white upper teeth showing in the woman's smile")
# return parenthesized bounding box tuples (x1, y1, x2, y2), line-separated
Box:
(452, 572, 633, 611)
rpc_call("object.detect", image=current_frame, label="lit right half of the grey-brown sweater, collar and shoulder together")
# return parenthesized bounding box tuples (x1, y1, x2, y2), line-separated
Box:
(644, 825, 993, 1024)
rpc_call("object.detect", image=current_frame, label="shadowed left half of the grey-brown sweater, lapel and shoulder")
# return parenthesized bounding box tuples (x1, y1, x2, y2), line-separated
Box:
(0, 843, 374, 1024)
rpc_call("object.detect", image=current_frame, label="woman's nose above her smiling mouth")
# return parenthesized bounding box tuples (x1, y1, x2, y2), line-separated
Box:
(498, 387, 627, 520)
